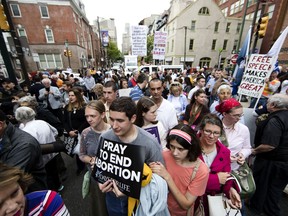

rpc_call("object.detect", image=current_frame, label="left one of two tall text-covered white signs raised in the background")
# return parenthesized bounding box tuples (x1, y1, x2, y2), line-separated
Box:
(131, 25, 148, 56)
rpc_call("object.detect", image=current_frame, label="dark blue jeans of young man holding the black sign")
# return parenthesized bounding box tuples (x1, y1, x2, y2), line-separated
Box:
(106, 192, 128, 216)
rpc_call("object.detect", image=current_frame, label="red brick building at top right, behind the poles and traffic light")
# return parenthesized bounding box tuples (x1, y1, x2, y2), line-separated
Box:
(214, 0, 288, 67)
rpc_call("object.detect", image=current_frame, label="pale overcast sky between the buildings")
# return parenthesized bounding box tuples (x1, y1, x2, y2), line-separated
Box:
(82, 0, 170, 50)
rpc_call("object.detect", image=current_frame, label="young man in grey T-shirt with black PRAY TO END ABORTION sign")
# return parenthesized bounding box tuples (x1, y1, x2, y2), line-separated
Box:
(93, 97, 163, 216)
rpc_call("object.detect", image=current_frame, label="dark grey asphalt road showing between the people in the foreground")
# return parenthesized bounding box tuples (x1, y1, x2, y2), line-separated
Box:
(60, 153, 288, 216)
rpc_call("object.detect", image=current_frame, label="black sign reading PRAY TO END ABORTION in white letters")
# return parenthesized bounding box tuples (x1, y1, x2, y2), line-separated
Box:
(92, 139, 145, 199)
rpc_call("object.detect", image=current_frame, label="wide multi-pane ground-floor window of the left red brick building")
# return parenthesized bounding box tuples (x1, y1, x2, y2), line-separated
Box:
(39, 53, 63, 69)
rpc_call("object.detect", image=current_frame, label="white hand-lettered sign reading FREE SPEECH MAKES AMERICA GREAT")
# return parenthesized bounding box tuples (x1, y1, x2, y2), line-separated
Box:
(238, 54, 277, 98)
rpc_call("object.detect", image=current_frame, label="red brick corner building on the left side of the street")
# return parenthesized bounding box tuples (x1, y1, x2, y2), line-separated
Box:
(7, 0, 100, 72)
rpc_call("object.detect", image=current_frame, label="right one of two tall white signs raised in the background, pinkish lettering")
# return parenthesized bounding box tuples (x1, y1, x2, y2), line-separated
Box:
(153, 31, 167, 60)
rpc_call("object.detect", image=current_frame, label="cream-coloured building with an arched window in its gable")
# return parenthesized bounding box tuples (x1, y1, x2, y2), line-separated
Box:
(163, 0, 251, 68)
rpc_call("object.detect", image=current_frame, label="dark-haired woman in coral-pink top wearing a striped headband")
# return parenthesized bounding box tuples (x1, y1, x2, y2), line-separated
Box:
(150, 124, 209, 216)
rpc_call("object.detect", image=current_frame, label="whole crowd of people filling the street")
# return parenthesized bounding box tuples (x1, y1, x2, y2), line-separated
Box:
(0, 66, 288, 216)
